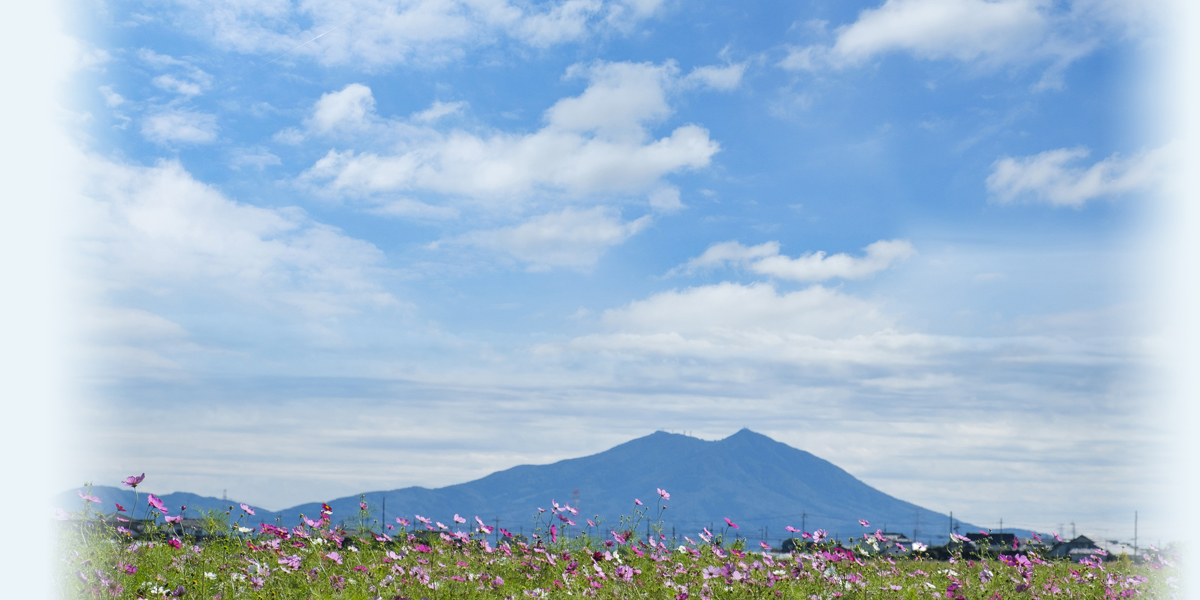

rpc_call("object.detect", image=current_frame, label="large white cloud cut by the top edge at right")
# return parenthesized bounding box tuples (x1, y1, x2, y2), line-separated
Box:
(779, 0, 1104, 83)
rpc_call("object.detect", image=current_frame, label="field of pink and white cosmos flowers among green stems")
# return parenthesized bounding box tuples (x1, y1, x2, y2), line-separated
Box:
(58, 478, 1176, 600)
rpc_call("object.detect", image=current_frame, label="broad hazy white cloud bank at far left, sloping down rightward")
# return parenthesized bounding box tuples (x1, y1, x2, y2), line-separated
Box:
(78, 158, 396, 317)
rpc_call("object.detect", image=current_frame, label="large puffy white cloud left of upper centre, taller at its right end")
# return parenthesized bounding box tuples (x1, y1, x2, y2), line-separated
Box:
(300, 62, 719, 199)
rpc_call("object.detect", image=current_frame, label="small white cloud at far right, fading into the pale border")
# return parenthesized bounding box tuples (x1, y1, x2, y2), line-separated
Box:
(988, 146, 1171, 208)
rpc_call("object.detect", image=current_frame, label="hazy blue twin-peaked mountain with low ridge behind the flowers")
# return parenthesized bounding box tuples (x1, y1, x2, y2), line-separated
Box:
(51, 430, 1027, 546)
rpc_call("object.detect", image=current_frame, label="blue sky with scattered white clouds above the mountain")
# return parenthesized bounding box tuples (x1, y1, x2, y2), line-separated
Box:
(59, 0, 1178, 539)
